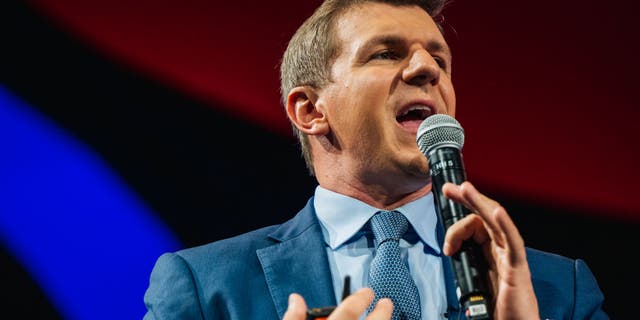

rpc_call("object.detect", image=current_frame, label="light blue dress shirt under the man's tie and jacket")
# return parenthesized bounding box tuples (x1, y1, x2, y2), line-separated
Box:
(313, 186, 447, 319)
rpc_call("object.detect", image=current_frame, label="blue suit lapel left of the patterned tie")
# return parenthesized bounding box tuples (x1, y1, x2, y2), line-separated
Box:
(256, 198, 336, 318)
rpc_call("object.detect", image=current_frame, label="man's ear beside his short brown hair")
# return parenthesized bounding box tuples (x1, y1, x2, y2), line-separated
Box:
(286, 86, 329, 135)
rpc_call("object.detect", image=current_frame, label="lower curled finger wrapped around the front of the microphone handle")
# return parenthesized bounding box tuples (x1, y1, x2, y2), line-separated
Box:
(442, 214, 489, 256)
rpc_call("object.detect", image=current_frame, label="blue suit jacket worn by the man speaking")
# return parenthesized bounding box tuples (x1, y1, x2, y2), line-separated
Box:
(144, 200, 608, 320)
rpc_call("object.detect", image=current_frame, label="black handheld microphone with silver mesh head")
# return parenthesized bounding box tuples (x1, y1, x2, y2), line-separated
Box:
(416, 114, 492, 320)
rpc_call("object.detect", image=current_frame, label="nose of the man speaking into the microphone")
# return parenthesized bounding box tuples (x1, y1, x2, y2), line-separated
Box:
(402, 49, 441, 86)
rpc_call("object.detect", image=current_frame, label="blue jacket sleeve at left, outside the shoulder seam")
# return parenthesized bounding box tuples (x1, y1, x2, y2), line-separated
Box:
(144, 253, 204, 320)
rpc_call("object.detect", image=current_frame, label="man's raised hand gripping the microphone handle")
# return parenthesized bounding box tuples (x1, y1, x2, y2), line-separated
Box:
(442, 182, 539, 320)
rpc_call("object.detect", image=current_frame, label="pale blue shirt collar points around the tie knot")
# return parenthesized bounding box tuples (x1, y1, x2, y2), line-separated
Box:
(313, 186, 440, 254)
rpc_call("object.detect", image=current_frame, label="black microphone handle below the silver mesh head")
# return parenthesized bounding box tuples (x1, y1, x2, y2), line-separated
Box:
(427, 147, 493, 320)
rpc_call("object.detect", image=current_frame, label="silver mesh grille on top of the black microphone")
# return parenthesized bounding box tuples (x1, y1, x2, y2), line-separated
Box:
(416, 114, 464, 155)
